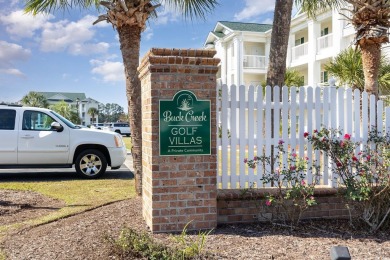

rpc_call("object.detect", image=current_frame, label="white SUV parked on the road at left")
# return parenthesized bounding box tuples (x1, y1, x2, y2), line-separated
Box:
(0, 105, 126, 178)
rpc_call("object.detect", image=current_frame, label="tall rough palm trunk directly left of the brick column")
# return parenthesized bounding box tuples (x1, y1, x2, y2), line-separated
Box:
(117, 25, 142, 195)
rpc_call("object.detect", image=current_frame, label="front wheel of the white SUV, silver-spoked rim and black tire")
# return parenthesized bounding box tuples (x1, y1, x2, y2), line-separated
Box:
(75, 149, 107, 179)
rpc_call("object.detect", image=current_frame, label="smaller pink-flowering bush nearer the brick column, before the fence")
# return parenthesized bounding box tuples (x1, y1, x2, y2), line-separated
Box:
(244, 140, 319, 225)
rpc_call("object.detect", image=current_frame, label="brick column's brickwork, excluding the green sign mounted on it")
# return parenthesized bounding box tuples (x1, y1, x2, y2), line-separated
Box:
(138, 48, 219, 232)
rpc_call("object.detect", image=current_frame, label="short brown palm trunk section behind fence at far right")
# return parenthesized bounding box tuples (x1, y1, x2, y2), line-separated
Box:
(360, 43, 381, 99)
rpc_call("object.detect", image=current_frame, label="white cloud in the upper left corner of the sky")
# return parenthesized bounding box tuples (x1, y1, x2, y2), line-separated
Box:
(0, 10, 54, 38)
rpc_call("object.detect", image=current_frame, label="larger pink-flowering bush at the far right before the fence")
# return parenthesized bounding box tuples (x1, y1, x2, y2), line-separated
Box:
(304, 128, 390, 232)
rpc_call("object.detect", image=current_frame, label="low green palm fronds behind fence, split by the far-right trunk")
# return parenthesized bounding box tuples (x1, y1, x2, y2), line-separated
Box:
(325, 48, 390, 94)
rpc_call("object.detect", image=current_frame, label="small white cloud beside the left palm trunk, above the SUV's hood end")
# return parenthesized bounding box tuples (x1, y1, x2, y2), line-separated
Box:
(90, 60, 125, 82)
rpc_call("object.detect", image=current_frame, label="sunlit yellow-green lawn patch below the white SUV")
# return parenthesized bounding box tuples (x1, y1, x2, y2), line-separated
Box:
(0, 179, 136, 236)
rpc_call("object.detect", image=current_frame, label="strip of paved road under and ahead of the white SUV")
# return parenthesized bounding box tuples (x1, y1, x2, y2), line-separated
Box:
(0, 155, 134, 182)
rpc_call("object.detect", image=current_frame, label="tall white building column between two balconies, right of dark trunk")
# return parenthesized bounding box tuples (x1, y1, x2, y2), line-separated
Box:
(307, 20, 321, 87)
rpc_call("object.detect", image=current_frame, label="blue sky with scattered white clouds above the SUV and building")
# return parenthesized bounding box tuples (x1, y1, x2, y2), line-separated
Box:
(0, 0, 275, 111)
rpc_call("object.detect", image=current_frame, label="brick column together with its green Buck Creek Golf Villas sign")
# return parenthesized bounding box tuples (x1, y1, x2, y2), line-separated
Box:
(138, 48, 220, 232)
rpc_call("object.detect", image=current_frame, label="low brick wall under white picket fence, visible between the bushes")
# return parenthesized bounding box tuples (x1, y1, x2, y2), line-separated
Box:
(217, 188, 349, 224)
